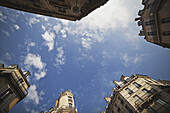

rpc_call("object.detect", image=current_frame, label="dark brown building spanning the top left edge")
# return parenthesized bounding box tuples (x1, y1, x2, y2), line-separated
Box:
(0, 0, 108, 21)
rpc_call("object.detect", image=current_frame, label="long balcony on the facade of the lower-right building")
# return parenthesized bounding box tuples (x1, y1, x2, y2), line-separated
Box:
(135, 89, 159, 110)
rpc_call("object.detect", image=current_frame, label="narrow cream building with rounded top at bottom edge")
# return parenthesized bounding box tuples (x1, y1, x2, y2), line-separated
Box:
(41, 90, 78, 113)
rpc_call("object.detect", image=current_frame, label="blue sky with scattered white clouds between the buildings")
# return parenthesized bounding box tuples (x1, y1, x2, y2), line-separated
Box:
(0, 0, 170, 113)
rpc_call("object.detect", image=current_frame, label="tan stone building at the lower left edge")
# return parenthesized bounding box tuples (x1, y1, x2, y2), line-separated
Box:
(0, 64, 30, 113)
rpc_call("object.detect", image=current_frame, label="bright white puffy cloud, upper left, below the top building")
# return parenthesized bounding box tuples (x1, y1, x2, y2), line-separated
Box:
(42, 31, 55, 51)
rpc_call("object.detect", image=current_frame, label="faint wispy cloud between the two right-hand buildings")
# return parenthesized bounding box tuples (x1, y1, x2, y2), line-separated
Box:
(121, 53, 145, 67)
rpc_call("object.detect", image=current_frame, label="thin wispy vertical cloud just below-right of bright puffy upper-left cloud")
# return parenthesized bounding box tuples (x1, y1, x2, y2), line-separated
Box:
(56, 47, 65, 66)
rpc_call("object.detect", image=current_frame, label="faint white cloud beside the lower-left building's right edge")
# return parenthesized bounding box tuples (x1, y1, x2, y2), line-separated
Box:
(25, 84, 40, 105)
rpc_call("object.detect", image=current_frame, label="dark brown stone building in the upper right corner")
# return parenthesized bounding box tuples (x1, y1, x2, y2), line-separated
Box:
(135, 0, 170, 48)
